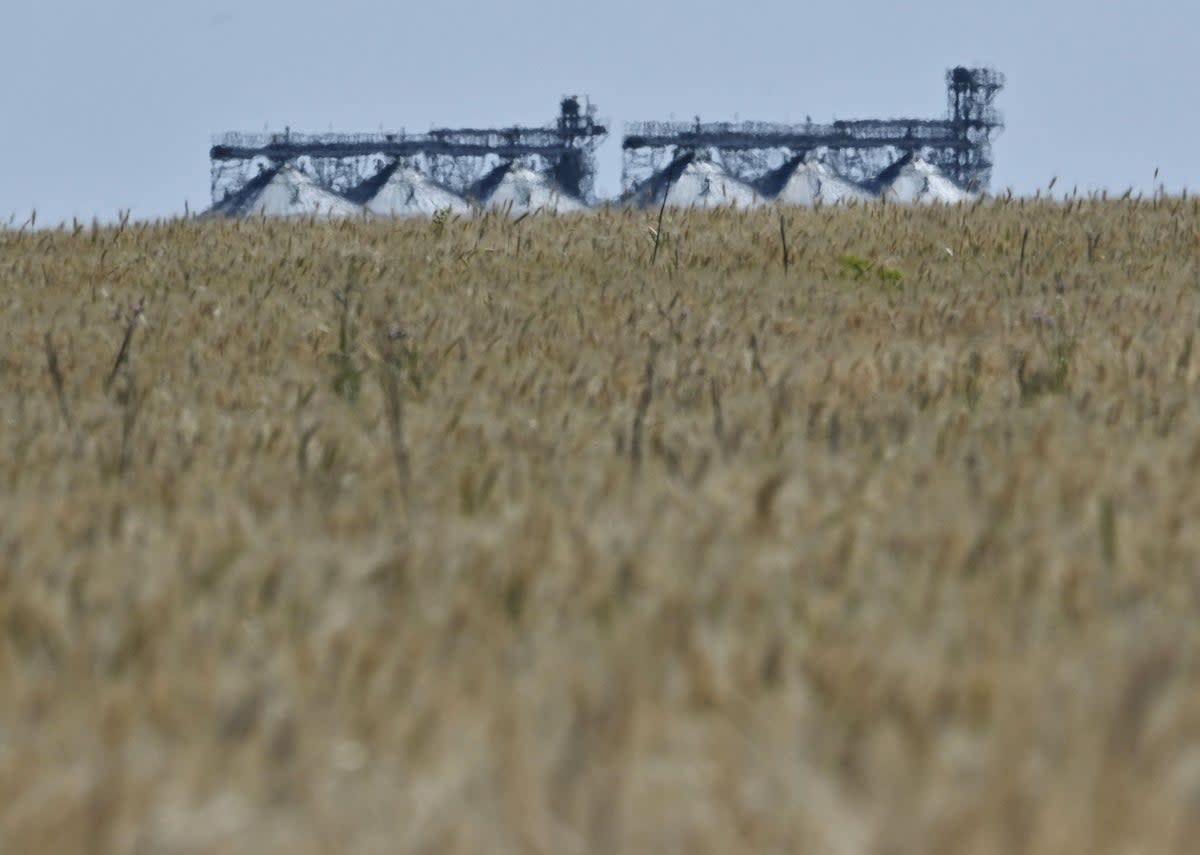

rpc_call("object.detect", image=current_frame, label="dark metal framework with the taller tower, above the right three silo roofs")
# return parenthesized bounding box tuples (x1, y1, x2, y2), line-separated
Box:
(622, 66, 1004, 192)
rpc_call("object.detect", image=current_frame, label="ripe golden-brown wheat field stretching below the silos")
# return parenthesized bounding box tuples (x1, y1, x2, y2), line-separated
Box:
(0, 196, 1200, 855)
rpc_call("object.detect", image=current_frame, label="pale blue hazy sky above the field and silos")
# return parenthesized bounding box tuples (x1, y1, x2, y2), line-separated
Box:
(0, 0, 1200, 222)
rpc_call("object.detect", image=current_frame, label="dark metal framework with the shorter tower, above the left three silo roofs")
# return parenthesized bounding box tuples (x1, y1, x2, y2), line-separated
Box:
(209, 95, 608, 204)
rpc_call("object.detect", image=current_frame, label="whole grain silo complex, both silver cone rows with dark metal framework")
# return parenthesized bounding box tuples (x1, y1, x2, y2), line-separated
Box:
(210, 67, 1004, 216)
